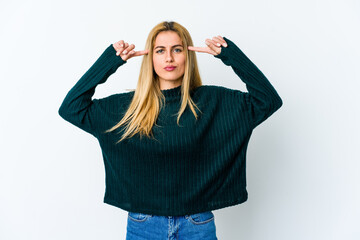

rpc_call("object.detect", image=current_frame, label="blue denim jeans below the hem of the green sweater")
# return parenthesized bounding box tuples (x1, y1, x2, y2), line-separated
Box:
(126, 211, 217, 240)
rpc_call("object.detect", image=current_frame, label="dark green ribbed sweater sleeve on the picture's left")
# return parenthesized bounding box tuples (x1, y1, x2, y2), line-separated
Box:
(58, 44, 126, 137)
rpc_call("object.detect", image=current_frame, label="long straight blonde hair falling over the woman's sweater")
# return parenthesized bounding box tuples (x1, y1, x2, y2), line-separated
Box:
(105, 21, 202, 143)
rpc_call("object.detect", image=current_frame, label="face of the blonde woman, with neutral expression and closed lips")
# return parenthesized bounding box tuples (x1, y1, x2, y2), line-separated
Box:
(153, 31, 186, 90)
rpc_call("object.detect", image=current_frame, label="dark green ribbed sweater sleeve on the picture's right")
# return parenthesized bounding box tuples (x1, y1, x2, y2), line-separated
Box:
(214, 37, 282, 128)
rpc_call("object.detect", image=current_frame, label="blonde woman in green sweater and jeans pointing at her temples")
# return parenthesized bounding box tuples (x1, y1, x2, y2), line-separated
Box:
(59, 22, 282, 239)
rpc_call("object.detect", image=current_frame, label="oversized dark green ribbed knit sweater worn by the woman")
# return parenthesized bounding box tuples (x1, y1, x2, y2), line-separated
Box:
(59, 37, 282, 216)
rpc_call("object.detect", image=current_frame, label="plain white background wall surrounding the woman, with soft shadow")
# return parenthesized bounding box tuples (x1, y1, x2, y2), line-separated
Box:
(0, 0, 360, 240)
